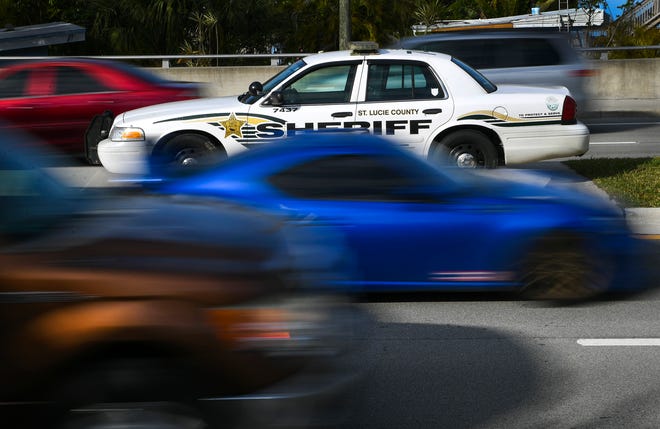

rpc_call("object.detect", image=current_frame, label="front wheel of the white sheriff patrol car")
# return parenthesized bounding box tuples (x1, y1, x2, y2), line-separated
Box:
(161, 133, 227, 167)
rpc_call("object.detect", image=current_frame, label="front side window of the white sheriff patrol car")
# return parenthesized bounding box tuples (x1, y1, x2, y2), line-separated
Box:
(282, 64, 357, 104)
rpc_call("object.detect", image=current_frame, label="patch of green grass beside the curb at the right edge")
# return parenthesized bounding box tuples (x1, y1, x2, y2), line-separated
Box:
(564, 158, 660, 207)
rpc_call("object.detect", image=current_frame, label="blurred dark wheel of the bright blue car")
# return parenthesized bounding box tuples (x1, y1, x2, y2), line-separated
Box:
(520, 233, 613, 301)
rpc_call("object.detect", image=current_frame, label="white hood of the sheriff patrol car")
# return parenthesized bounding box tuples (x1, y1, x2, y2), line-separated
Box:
(119, 96, 242, 125)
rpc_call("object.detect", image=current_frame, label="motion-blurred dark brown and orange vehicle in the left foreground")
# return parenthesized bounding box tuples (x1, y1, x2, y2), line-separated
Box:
(0, 133, 355, 428)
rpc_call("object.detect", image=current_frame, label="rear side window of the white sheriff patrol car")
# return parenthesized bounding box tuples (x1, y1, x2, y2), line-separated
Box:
(366, 62, 445, 101)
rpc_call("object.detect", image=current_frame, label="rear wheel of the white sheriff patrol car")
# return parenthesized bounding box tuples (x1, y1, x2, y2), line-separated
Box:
(434, 130, 497, 168)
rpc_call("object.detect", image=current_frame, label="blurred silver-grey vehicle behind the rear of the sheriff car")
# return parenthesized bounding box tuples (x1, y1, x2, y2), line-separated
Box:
(393, 30, 596, 111)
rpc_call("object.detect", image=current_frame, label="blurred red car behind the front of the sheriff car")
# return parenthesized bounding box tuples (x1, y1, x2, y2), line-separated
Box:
(0, 59, 202, 163)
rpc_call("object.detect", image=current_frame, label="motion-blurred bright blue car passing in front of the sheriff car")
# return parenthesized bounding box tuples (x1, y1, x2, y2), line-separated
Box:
(152, 133, 637, 299)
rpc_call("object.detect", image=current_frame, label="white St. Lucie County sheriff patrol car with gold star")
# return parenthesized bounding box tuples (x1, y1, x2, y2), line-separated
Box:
(98, 43, 589, 173)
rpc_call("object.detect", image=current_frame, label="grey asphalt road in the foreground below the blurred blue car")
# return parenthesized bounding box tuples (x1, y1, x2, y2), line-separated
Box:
(345, 252, 660, 429)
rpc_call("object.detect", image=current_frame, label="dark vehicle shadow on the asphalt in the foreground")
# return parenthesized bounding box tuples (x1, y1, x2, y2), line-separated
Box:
(343, 322, 565, 429)
